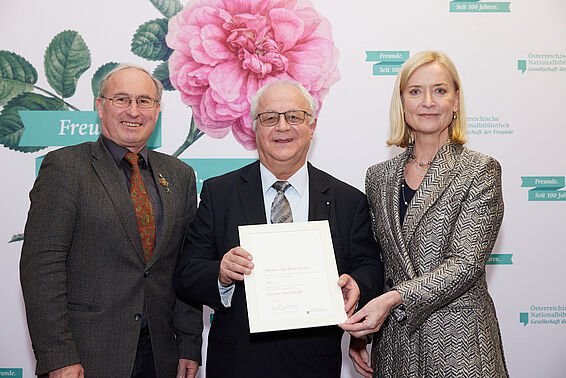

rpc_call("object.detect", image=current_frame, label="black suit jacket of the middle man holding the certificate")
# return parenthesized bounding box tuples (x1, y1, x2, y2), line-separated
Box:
(175, 162, 383, 378)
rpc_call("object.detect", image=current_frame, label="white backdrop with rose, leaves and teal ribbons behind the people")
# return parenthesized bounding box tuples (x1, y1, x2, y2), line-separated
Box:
(0, 0, 566, 378)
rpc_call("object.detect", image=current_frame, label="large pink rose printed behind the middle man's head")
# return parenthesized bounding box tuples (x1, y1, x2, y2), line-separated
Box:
(166, 0, 340, 150)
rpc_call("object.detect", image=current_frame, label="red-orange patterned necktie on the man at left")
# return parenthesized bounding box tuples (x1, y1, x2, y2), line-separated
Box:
(125, 152, 155, 263)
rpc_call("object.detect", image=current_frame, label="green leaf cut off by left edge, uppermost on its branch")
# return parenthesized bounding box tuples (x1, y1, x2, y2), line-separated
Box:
(0, 50, 37, 106)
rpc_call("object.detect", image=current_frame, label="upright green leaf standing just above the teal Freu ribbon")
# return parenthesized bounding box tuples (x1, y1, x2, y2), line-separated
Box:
(44, 30, 90, 98)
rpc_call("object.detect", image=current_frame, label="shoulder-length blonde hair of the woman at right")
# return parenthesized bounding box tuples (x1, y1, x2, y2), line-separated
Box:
(386, 51, 466, 147)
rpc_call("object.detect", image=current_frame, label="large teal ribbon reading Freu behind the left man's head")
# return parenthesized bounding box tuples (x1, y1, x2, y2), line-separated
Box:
(20, 110, 161, 149)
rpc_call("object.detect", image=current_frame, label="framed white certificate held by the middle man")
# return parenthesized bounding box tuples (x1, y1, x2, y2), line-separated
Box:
(238, 220, 347, 333)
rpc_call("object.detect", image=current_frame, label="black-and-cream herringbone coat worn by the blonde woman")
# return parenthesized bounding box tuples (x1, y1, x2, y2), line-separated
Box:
(366, 143, 508, 378)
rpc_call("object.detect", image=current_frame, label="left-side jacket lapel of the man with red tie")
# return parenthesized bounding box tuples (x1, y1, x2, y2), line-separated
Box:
(92, 138, 145, 264)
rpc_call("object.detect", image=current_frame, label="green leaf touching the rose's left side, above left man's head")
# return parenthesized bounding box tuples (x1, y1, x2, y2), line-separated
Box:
(131, 18, 173, 60)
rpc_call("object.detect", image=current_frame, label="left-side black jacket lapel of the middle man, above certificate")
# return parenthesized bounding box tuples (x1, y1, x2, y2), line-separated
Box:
(238, 160, 267, 224)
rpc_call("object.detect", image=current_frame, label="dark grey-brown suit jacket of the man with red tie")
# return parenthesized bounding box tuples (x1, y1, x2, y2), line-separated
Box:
(20, 139, 202, 378)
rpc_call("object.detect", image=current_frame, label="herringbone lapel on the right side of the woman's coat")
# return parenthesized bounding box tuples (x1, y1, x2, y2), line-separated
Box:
(402, 142, 463, 244)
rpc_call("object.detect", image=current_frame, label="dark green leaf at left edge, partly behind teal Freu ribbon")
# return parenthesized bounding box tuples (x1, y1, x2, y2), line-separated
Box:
(0, 92, 68, 152)
